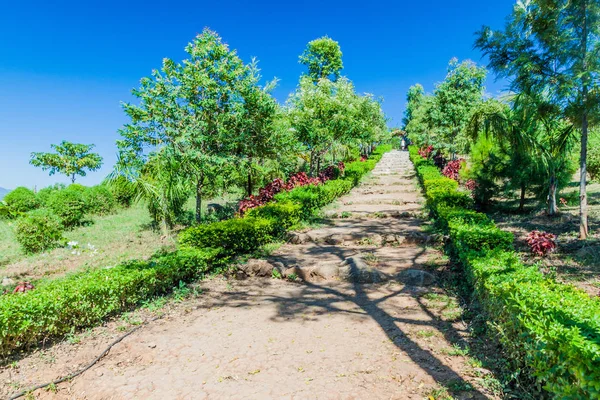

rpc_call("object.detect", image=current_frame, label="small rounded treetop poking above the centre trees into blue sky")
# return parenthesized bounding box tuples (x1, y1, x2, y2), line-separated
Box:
(300, 36, 344, 83)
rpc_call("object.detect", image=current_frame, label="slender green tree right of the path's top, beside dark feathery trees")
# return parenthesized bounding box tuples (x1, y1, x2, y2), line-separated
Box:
(433, 58, 487, 155)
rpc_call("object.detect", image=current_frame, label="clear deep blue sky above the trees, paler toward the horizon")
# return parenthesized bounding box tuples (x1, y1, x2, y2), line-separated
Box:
(0, 0, 514, 189)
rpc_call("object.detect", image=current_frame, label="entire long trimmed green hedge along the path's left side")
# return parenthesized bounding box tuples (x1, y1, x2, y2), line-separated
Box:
(0, 146, 391, 356)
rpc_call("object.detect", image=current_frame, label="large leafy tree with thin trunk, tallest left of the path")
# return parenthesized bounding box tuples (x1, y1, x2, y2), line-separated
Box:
(117, 29, 264, 221)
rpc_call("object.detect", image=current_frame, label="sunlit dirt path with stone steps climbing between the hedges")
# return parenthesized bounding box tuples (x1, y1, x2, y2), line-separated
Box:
(0, 151, 499, 400)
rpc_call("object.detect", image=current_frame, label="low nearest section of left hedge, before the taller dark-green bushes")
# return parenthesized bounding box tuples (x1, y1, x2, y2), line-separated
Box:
(0, 248, 222, 356)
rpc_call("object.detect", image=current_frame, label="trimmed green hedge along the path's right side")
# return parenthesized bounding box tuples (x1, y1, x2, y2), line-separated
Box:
(410, 148, 600, 399)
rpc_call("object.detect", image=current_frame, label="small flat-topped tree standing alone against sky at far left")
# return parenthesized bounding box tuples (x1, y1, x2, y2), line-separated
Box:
(29, 140, 102, 183)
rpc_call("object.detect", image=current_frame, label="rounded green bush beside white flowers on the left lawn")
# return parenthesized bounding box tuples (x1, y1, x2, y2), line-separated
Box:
(16, 208, 64, 254)
